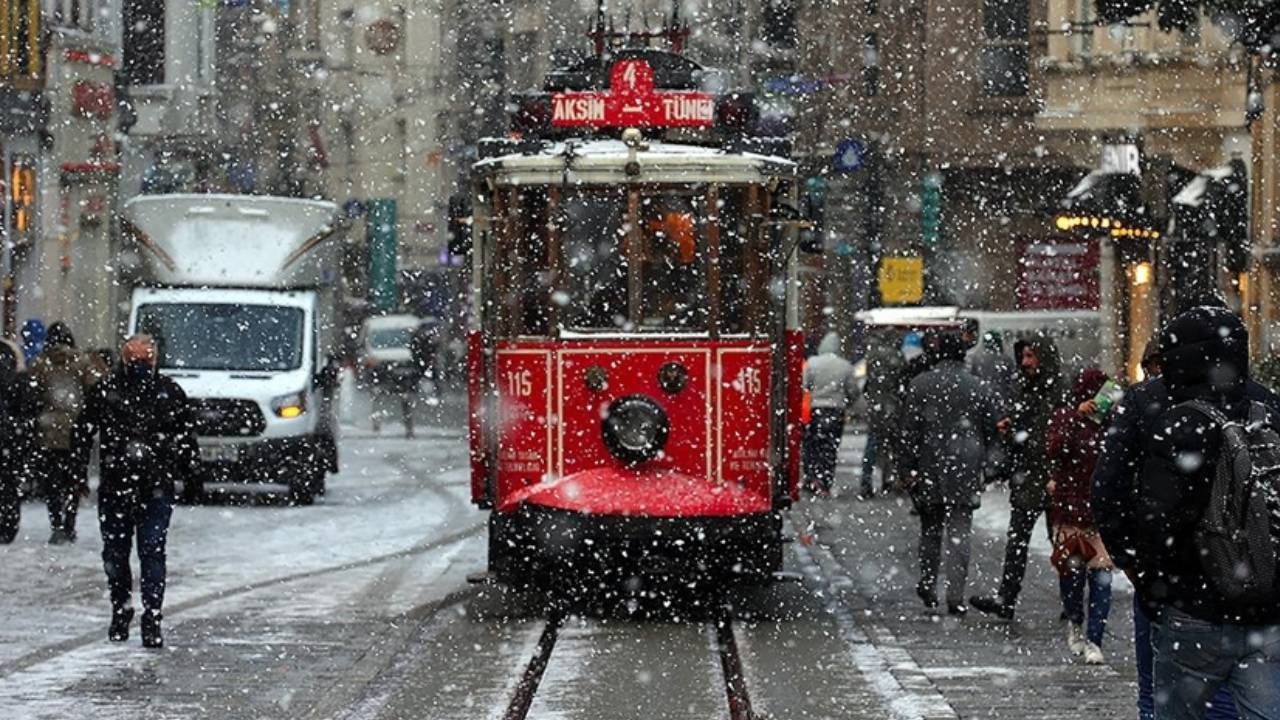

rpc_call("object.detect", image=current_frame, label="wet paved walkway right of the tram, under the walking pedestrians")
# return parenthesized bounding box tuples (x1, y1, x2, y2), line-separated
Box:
(792, 434, 1137, 720)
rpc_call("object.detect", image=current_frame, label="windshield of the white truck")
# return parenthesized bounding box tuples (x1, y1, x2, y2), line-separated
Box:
(137, 302, 302, 372)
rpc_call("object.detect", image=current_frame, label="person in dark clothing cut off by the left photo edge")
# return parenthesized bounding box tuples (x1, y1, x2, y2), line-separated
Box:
(0, 341, 36, 544)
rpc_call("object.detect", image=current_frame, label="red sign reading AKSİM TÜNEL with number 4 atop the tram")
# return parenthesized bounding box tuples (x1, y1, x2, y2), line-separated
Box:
(552, 60, 716, 128)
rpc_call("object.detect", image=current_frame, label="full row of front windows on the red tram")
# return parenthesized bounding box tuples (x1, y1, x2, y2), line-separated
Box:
(494, 179, 773, 336)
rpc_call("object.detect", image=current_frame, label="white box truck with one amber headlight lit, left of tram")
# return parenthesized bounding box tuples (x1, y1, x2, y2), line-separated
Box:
(124, 195, 342, 505)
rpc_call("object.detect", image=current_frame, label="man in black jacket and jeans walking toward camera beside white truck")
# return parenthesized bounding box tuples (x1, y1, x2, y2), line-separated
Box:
(86, 336, 200, 647)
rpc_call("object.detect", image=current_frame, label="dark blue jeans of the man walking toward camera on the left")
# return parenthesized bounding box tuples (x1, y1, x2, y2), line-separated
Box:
(97, 493, 173, 614)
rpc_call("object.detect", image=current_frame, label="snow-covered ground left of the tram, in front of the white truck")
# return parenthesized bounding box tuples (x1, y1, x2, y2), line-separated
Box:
(0, 420, 483, 667)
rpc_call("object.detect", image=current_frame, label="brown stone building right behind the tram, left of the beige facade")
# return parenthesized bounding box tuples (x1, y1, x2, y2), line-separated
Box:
(792, 0, 1083, 345)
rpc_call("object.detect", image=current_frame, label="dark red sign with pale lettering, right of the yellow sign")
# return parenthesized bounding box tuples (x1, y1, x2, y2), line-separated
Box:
(1018, 237, 1098, 310)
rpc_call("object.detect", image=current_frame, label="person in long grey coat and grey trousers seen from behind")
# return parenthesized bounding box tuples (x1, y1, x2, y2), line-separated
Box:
(901, 333, 998, 615)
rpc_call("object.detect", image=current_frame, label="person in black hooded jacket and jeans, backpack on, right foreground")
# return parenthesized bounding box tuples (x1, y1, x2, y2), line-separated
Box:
(1121, 306, 1280, 720)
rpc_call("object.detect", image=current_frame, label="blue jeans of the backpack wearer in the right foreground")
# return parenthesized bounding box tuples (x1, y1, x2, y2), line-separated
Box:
(1151, 609, 1280, 720)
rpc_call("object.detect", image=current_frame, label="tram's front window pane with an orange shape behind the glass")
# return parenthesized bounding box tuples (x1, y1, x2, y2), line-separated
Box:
(640, 192, 708, 331)
